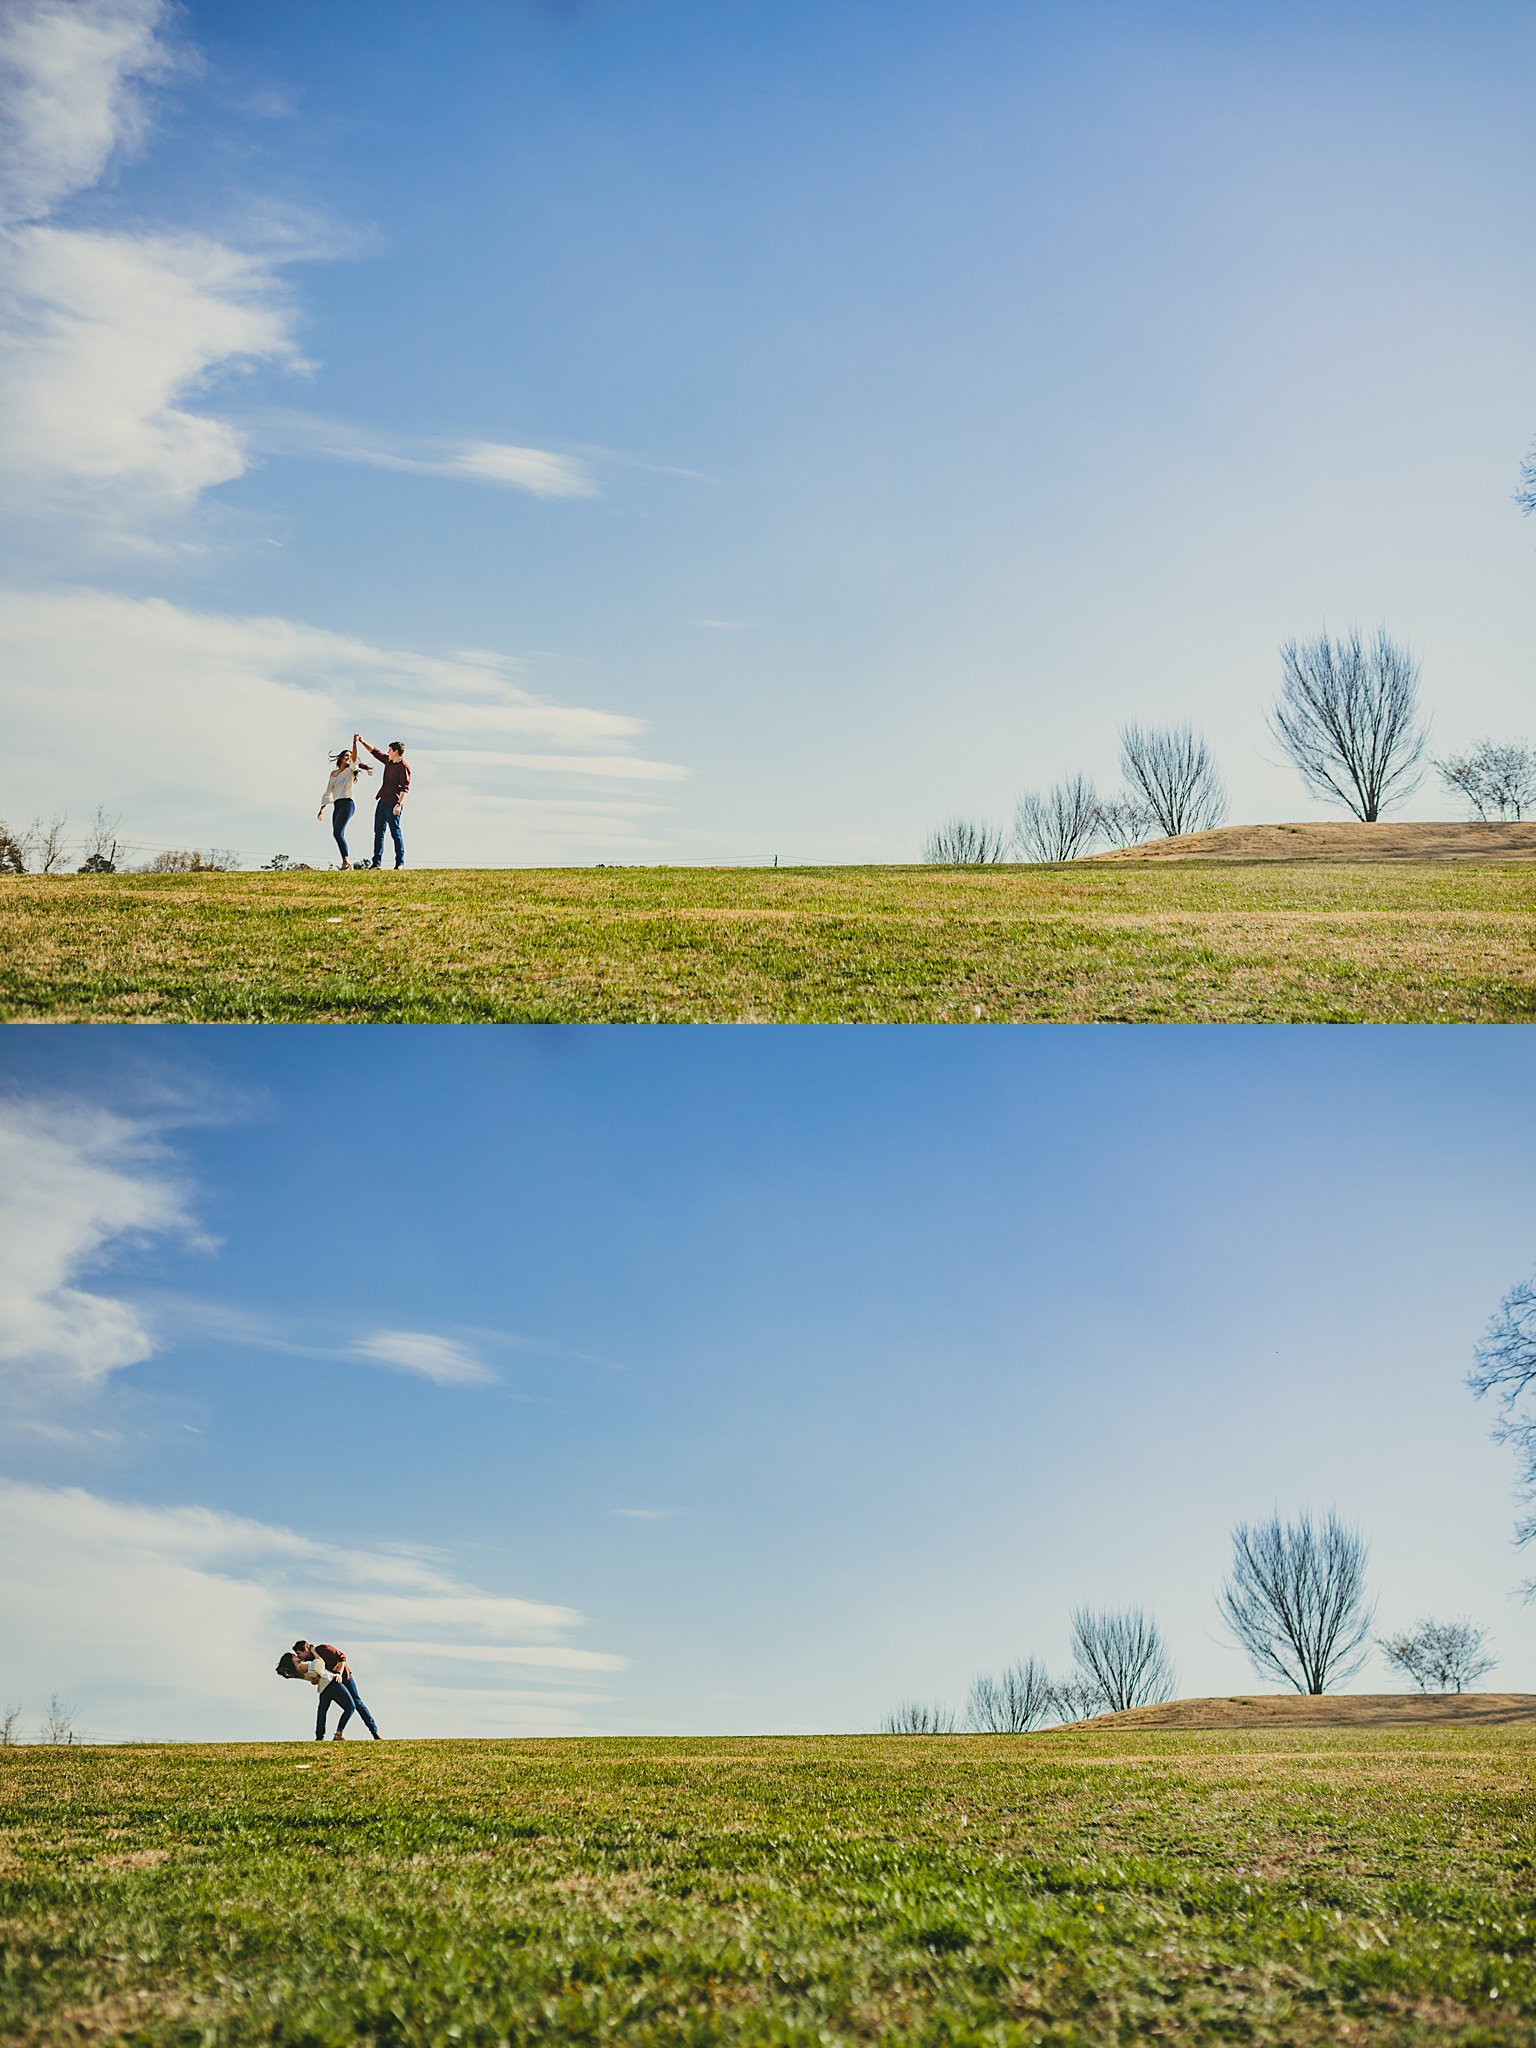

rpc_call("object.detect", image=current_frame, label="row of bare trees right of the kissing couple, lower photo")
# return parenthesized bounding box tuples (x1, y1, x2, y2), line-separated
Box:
(885, 1511, 1497, 1735)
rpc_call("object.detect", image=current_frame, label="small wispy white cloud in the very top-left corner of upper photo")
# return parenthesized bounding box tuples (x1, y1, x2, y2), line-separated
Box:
(0, 0, 168, 223)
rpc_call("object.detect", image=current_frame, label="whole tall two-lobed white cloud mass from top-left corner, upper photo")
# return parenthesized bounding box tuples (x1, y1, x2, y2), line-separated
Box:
(0, 0, 299, 528)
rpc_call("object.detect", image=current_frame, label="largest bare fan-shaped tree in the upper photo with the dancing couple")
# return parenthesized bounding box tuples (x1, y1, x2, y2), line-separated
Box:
(1270, 629, 1427, 825)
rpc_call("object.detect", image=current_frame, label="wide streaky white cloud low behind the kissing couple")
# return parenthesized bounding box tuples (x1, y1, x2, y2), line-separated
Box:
(0, 1481, 625, 1741)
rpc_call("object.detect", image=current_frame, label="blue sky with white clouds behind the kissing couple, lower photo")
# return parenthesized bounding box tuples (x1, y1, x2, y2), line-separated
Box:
(0, 1026, 1536, 1737)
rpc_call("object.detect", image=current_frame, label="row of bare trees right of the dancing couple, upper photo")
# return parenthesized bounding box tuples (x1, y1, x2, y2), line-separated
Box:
(924, 634, 1536, 866)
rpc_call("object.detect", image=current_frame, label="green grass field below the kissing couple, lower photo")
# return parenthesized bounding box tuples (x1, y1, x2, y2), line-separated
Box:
(0, 1726, 1536, 2048)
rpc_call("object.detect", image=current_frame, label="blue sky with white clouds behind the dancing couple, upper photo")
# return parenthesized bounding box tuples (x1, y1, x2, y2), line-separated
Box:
(0, 0, 1536, 864)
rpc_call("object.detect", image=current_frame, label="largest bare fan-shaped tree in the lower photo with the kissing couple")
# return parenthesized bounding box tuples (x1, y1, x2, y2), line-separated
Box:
(1219, 1511, 1376, 1694)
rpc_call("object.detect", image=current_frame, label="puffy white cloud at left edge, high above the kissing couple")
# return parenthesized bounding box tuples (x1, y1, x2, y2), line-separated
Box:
(0, 1102, 188, 1397)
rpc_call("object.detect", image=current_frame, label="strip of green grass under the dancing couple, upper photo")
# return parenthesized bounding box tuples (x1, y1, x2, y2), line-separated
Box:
(0, 862, 1536, 1024)
